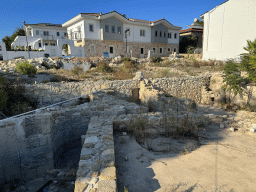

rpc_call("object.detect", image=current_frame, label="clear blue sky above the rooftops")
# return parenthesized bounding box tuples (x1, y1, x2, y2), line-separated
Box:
(0, 0, 225, 41)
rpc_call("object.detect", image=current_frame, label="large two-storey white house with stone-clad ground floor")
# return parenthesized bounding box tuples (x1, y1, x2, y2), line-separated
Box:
(62, 11, 181, 57)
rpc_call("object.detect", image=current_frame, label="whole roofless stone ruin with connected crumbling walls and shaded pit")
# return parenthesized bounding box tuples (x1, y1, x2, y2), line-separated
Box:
(0, 73, 255, 192)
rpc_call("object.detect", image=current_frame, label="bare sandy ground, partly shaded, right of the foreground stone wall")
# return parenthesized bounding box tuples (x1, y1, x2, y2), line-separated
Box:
(115, 106, 256, 192)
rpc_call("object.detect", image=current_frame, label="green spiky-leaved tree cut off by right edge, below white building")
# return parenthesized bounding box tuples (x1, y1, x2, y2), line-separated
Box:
(240, 39, 256, 82)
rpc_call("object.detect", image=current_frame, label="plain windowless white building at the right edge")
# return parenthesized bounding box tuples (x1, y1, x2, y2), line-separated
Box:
(201, 0, 256, 60)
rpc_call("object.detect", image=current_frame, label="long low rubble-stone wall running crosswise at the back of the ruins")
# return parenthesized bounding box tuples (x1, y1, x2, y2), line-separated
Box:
(25, 76, 210, 106)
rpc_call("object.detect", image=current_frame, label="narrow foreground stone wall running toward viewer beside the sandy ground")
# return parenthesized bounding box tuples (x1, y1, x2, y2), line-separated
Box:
(75, 116, 117, 192)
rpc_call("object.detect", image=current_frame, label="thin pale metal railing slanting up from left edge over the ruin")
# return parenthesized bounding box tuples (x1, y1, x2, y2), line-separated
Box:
(0, 80, 136, 122)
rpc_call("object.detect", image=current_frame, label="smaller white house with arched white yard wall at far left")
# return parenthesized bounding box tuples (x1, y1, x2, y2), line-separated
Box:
(0, 23, 85, 60)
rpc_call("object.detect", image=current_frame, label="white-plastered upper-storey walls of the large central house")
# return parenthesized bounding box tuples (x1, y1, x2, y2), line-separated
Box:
(62, 11, 181, 44)
